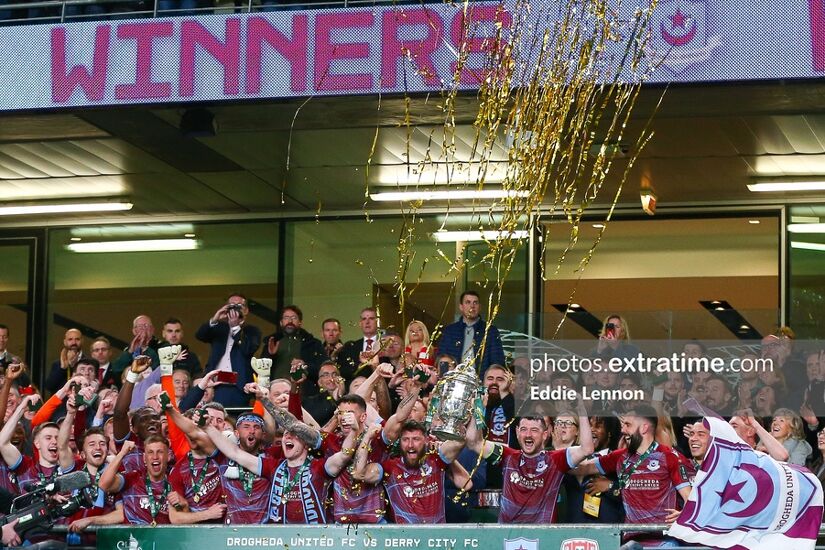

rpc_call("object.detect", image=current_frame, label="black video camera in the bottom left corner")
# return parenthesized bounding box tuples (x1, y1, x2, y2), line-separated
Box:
(0, 471, 97, 539)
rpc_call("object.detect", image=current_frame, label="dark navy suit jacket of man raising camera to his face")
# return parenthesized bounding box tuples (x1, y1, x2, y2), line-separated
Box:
(195, 321, 261, 407)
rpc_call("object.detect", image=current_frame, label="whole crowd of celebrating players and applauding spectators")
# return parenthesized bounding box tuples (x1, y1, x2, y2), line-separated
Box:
(0, 291, 825, 546)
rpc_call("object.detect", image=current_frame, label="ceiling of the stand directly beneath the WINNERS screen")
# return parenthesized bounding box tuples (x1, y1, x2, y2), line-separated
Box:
(0, 78, 825, 226)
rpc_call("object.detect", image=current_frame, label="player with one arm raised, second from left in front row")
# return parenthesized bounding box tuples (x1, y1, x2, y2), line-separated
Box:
(57, 394, 123, 544)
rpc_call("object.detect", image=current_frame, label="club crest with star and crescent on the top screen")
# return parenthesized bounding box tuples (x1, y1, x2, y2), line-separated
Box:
(653, 0, 722, 74)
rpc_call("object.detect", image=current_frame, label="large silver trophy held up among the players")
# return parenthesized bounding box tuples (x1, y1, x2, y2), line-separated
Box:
(427, 363, 481, 441)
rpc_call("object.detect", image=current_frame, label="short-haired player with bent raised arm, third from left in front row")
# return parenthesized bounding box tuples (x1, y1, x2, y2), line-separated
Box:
(99, 435, 172, 527)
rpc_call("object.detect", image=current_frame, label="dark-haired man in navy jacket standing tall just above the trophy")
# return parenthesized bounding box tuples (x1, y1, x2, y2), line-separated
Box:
(438, 290, 504, 376)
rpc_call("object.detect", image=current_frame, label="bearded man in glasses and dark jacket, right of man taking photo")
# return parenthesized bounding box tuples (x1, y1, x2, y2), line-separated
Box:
(261, 305, 324, 394)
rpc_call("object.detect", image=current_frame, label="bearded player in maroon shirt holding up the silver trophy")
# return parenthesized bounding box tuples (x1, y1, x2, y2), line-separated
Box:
(352, 420, 466, 523)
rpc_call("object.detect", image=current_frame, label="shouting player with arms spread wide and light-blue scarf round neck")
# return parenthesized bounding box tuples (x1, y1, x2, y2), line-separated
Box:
(206, 414, 355, 524)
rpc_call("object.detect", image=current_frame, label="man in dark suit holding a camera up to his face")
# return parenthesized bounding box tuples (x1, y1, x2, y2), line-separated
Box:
(195, 293, 261, 407)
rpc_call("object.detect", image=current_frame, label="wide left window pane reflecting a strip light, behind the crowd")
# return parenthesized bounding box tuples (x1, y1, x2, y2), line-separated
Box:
(47, 222, 278, 370)
